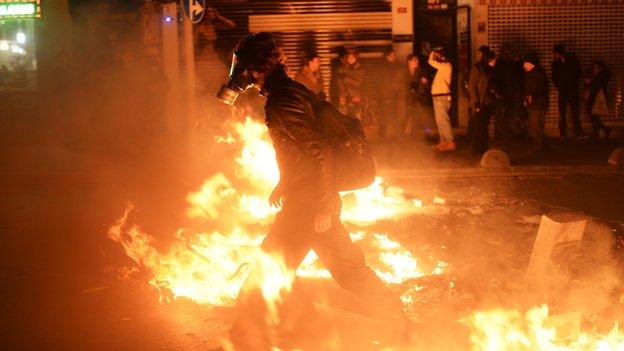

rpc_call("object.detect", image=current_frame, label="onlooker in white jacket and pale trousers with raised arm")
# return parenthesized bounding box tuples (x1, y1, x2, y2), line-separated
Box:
(428, 47, 455, 151)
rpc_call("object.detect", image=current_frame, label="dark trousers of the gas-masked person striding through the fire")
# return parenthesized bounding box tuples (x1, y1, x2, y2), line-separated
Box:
(230, 199, 404, 351)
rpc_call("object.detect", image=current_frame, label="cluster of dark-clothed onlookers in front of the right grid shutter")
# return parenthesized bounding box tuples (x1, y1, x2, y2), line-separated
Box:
(467, 45, 611, 155)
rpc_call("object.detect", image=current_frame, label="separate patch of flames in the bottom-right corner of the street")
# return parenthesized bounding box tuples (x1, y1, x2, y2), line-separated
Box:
(463, 305, 624, 351)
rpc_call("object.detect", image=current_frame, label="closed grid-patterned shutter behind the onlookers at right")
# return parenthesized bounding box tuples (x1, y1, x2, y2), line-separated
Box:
(488, 0, 624, 128)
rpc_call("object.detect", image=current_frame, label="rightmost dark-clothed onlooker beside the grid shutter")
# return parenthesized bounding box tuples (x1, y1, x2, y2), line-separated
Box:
(584, 61, 611, 139)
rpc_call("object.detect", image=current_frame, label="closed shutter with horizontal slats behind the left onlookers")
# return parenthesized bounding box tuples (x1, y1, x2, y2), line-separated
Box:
(196, 0, 392, 104)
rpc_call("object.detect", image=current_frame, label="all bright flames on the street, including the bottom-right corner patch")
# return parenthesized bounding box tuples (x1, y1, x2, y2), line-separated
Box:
(108, 118, 624, 351)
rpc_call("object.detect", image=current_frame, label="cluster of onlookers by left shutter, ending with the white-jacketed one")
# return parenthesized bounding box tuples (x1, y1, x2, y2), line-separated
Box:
(295, 48, 455, 151)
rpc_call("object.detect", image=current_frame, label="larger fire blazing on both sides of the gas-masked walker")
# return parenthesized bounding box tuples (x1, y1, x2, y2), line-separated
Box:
(109, 118, 438, 306)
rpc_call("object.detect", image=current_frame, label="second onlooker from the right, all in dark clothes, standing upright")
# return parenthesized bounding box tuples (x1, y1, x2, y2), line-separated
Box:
(551, 45, 587, 139)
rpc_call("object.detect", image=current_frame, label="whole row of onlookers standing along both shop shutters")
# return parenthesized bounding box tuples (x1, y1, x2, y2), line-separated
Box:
(295, 45, 611, 155)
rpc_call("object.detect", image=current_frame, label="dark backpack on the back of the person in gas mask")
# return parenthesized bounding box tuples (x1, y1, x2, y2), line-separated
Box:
(312, 93, 377, 191)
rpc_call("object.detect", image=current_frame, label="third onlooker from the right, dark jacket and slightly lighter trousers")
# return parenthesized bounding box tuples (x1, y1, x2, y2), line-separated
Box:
(522, 52, 548, 151)
